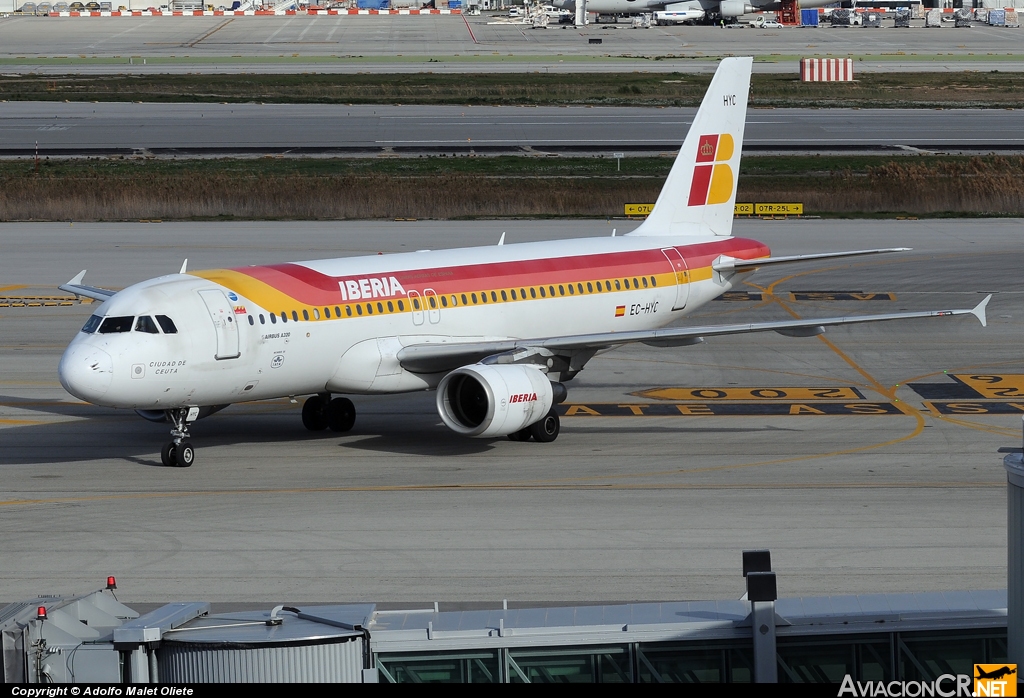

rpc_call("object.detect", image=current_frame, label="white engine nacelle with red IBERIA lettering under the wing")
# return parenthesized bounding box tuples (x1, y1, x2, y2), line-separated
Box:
(437, 363, 553, 439)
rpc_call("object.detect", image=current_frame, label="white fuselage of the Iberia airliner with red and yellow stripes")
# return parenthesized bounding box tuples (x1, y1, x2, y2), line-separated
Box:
(59, 231, 768, 410)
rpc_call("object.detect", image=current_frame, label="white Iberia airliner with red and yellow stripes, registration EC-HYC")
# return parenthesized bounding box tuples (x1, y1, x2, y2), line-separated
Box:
(58, 57, 990, 467)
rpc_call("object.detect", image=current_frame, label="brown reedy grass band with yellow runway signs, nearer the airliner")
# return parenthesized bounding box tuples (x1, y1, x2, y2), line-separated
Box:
(0, 156, 1024, 221)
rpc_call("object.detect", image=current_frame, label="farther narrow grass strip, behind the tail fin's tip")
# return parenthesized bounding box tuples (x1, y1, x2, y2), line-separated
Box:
(6, 71, 1024, 108)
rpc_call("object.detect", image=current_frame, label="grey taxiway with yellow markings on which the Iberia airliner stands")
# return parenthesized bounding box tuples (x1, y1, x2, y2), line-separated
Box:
(0, 220, 1024, 603)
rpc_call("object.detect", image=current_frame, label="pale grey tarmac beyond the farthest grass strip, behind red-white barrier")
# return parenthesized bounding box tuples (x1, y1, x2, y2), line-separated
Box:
(0, 13, 1024, 75)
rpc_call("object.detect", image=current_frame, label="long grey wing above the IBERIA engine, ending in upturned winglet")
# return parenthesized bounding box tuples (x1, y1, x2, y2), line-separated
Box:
(397, 294, 992, 374)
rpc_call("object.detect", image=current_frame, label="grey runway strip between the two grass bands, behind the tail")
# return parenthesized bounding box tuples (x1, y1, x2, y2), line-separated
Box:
(8, 102, 1024, 157)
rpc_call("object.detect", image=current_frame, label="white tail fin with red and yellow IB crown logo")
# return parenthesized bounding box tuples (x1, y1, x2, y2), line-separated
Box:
(629, 58, 754, 236)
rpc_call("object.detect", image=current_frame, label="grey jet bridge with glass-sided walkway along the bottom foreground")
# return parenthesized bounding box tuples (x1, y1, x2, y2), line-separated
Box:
(0, 572, 1008, 684)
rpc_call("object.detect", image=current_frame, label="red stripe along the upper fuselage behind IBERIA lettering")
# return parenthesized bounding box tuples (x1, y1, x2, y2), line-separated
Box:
(224, 237, 769, 305)
